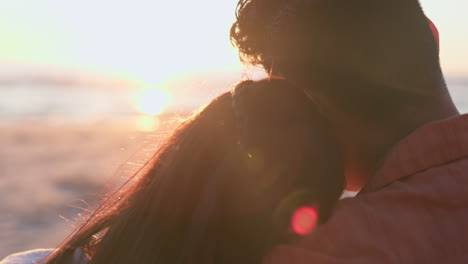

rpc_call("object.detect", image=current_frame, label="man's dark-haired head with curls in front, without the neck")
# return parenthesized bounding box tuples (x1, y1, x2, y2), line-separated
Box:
(231, 0, 445, 119)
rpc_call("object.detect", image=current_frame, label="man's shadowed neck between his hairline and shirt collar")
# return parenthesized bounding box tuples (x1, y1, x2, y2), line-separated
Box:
(332, 94, 459, 191)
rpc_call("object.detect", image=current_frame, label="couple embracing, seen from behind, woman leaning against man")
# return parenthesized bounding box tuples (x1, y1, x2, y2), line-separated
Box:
(0, 0, 468, 264)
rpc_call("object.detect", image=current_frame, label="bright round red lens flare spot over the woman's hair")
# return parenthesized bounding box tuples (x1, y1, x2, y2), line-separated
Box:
(291, 206, 318, 236)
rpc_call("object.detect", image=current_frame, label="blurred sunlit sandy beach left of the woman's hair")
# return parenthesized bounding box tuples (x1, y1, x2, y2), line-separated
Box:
(0, 120, 182, 259)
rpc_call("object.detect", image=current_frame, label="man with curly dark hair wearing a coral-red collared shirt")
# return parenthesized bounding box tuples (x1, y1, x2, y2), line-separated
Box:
(231, 0, 468, 264)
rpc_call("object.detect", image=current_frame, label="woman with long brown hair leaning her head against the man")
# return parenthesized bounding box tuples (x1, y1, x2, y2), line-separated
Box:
(2, 79, 344, 264)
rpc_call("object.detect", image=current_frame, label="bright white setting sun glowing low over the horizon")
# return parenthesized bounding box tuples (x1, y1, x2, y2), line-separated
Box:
(135, 88, 171, 115)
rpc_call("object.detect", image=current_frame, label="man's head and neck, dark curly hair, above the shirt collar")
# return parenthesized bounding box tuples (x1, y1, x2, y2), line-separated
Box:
(231, 0, 457, 190)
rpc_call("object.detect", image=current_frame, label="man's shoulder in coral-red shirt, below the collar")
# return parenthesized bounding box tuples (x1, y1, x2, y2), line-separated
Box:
(268, 168, 468, 264)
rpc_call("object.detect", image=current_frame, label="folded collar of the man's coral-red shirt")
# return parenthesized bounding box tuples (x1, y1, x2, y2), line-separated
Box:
(361, 114, 468, 193)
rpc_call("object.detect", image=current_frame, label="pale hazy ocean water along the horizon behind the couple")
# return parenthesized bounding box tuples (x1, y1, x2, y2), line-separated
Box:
(0, 78, 468, 124)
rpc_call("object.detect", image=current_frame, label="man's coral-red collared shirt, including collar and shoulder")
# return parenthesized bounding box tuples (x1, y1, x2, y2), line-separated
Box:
(265, 115, 468, 264)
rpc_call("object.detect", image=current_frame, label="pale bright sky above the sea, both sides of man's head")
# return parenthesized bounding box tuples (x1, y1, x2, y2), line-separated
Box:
(0, 0, 468, 83)
